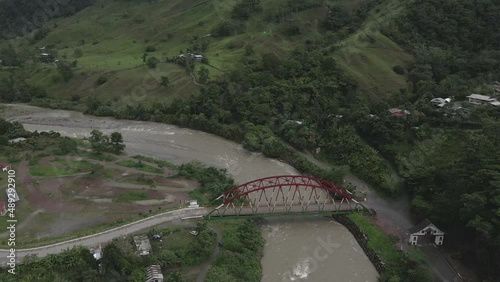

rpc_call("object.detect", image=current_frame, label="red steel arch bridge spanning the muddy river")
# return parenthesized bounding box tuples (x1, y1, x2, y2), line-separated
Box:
(204, 175, 367, 219)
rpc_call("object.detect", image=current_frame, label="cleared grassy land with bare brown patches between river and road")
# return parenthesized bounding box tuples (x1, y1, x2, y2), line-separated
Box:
(0, 137, 198, 245)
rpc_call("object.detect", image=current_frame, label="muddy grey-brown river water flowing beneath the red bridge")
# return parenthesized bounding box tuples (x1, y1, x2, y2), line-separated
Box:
(0, 105, 378, 282)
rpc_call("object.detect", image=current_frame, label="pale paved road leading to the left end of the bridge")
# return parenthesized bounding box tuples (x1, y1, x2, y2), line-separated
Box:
(0, 208, 209, 265)
